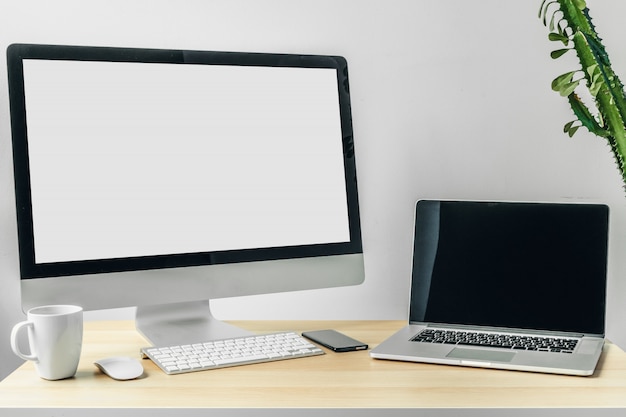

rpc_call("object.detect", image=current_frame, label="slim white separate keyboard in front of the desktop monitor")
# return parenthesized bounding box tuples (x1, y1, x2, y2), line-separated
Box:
(141, 332, 324, 375)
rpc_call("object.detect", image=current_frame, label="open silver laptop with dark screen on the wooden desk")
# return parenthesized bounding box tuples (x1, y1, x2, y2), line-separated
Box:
(370, 200, 609, 376)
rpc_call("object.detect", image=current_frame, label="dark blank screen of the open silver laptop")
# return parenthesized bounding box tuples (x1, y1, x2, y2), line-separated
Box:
(410, 200, 608, 335)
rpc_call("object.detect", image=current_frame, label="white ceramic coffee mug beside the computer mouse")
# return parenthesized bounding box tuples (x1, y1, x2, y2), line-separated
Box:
(11, 305, 83, 380)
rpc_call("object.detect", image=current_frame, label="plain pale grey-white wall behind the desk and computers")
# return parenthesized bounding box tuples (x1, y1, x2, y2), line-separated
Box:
(0, 0, 626, 378)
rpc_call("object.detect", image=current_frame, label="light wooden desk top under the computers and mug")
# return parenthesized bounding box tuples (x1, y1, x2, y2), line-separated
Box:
(0, 321, 626, 417)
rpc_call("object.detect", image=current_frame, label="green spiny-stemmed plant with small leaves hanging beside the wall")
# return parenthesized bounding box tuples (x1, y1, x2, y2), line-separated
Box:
(539, 0, 626, 184)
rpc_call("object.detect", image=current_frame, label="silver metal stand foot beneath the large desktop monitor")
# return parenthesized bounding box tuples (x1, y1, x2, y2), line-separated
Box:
(135, 300, 252, 346)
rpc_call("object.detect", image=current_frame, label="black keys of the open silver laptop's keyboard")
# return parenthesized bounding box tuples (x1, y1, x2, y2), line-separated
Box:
(411, 329, 578, 353)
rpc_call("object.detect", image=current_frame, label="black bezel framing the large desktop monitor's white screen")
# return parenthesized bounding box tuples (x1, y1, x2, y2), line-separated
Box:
(7, 44, 362, 279)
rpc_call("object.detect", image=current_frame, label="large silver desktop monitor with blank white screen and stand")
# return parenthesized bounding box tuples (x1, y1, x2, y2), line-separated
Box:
(7, 44, 364, 344)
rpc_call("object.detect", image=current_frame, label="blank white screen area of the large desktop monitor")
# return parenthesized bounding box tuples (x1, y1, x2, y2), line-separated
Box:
(24, 59, 349, 263)
